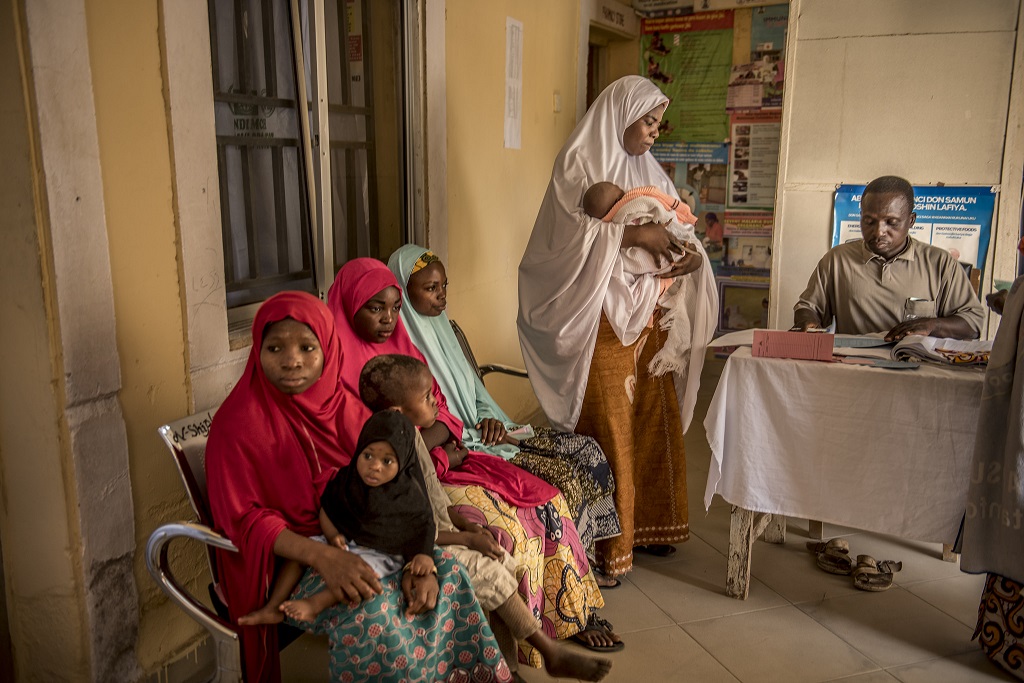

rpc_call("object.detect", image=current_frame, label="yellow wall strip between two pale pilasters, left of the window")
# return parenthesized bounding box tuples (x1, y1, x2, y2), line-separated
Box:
(86, 0, 208, 671)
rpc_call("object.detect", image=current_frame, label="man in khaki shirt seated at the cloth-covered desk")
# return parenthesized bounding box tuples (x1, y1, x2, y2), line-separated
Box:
(793, 175, 984, 341)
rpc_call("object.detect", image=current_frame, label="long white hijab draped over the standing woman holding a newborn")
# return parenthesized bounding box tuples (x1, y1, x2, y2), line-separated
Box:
(518, 76, 702, 431)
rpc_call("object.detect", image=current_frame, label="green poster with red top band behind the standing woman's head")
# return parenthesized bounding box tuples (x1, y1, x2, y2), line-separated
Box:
(640, 10, 732, 143)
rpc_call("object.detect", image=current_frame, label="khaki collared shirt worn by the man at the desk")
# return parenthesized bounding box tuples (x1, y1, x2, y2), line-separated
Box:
(794, 238, 985, 334)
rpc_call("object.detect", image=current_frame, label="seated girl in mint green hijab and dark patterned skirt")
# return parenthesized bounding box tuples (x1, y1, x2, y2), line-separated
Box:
(388, 245, 622, 566)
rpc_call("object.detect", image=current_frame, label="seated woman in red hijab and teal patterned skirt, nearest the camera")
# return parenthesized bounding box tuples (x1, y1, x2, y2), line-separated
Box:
(206, 292, 511, 681)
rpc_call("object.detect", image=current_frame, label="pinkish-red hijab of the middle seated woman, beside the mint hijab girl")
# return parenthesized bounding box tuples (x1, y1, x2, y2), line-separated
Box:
(327, 258, 559, 507)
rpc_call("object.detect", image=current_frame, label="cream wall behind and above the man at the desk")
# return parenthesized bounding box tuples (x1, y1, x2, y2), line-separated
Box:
(771, 0, 1022, 328)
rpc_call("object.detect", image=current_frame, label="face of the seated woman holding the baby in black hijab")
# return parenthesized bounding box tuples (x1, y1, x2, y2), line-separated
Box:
(259, 317, 324, 395)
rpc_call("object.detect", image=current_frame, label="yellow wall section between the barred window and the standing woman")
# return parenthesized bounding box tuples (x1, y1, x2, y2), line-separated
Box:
(445, 0, 579, 418)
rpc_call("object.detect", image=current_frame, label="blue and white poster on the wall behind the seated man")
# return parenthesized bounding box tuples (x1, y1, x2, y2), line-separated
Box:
(833, 185, 995, 269)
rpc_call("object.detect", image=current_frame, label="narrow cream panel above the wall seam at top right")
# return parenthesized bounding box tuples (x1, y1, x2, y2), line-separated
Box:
(800, 0, 1018, 39)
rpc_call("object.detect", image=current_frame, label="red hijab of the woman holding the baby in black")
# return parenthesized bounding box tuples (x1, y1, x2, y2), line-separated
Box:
(206, 292, 370, 681)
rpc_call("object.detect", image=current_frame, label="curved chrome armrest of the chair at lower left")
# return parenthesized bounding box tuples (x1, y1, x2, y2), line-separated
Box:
(145, 522, 244, 682)
